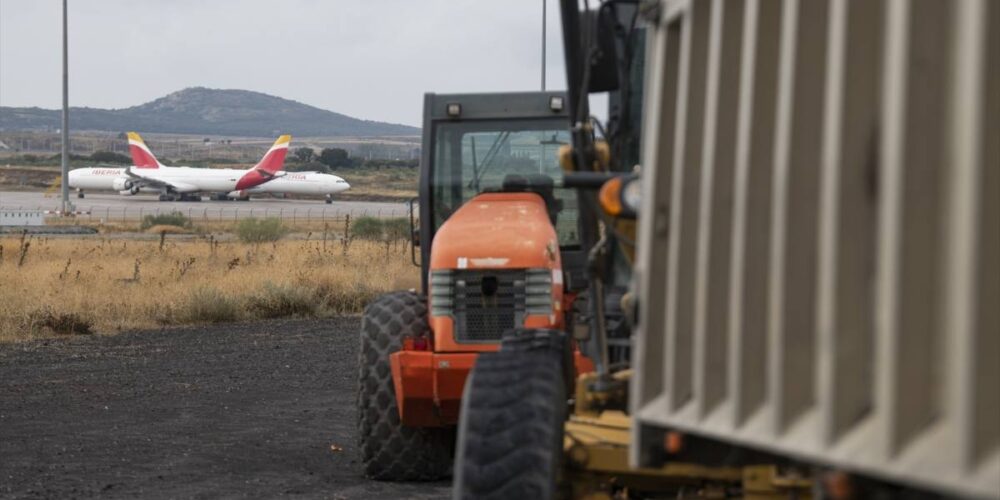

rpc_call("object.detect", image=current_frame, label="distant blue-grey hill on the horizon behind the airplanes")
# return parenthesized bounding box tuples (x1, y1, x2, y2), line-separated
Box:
(0, 87, 420, 137)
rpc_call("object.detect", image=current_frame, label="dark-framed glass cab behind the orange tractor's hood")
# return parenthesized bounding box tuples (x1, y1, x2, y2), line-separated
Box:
(419, 92, 582, 294)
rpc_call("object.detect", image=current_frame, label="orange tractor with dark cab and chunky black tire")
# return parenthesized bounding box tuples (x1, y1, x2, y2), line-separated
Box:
(357, 92, 593, 480)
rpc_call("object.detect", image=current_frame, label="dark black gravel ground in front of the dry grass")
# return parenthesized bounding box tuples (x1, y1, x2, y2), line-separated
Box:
(0, 318, 450, 499)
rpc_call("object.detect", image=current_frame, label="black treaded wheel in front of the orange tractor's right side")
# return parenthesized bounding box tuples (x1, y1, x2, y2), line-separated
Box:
(453, 329, 567, 499)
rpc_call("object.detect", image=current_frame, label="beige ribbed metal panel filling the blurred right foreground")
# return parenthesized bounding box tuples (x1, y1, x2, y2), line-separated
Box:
(631, 0, 1000, 496)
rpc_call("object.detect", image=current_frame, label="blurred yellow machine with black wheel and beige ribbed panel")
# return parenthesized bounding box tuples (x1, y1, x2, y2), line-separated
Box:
(455, 0, 1000, 498)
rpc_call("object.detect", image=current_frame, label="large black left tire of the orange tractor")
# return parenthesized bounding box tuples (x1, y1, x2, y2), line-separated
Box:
(357, 292, 455, 481)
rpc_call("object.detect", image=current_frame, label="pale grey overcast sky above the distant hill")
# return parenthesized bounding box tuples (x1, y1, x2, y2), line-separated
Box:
(0, 0, 565, 126)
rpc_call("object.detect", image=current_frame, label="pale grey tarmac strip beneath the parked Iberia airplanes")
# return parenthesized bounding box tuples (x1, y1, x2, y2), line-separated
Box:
(0, 191, 409, 221)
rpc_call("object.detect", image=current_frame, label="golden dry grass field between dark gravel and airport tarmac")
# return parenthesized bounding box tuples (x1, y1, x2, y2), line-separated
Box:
(0, 235, 419, 341)
